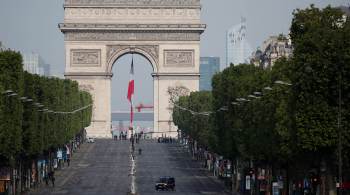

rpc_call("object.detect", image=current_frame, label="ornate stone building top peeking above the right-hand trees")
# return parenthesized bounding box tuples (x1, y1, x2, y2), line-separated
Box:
(250, 34, 293, 68)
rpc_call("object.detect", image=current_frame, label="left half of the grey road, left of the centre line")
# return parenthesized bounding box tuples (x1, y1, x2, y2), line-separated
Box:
(29, 139, 130, 195)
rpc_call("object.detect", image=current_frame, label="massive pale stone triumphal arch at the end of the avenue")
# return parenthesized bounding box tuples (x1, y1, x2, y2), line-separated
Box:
(59, 0, 205, 137)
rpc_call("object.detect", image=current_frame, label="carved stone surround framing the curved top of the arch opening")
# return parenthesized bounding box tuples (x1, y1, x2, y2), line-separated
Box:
(106, 45, 159, 73)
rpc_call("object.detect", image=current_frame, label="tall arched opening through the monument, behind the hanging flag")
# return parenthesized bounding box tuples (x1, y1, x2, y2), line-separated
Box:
(108, 51, 156, 139)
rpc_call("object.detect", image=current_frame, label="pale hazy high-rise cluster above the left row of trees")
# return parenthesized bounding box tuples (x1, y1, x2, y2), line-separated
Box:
(22, 53, 50, 76)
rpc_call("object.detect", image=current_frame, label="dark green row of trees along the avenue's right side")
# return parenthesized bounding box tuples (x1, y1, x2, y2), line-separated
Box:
(173, 6, 350, 187)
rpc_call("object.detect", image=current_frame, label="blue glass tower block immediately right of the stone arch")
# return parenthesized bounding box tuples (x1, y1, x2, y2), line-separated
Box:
(199, 57, 220, 91)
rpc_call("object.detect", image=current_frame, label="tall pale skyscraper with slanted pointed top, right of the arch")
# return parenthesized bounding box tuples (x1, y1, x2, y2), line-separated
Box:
(226, 18, 252, 66)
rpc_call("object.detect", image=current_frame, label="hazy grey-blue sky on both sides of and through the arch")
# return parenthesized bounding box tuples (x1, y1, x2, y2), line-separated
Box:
(0, 0, 350, 116)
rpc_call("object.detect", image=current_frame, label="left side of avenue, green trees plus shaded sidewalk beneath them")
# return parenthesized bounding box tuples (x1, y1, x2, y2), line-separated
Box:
(0, 50, 92, 194)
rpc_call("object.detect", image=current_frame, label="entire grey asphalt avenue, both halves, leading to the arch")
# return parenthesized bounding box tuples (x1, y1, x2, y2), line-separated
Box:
(30, 140, 230, 195)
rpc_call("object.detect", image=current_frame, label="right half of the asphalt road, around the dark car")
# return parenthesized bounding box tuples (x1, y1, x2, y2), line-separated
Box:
(136, 141, 230, 195)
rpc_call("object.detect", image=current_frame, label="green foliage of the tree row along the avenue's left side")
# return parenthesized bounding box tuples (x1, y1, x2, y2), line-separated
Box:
(0, 50, 92, 166)
